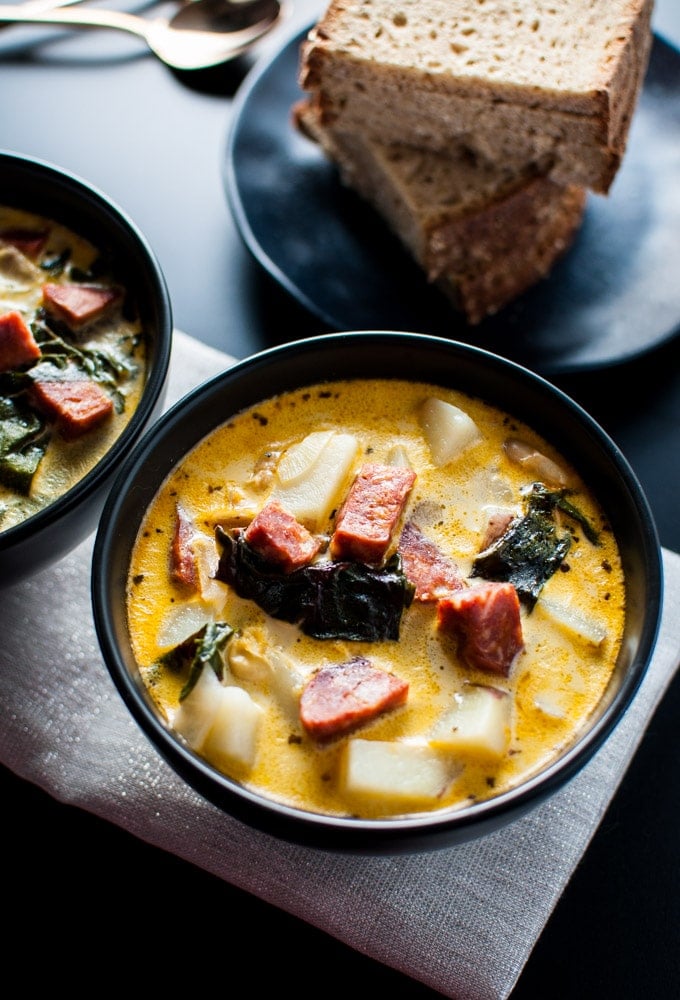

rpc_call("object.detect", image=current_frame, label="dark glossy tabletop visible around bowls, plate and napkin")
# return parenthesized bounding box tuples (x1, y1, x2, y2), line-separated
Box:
(0, 0, 680, 1000)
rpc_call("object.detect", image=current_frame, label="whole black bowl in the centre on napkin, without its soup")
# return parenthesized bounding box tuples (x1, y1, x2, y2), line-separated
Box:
(92, 331, 662, 853)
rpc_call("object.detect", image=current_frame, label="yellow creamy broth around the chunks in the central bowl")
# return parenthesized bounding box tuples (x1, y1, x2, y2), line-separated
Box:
(127, 380, 625, 817)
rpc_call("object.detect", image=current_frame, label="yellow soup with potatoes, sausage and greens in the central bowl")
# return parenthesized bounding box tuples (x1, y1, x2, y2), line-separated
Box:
(127, 379, 625, 817)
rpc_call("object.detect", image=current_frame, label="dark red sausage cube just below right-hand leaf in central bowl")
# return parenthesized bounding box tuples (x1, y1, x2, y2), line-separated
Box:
(437, 580, 524, 677)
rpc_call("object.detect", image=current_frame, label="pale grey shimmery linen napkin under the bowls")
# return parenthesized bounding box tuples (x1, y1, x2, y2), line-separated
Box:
(0, 332, 680, 1000)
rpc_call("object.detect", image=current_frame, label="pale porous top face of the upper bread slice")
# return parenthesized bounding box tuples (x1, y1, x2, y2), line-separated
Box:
(317, 0, 652, 93)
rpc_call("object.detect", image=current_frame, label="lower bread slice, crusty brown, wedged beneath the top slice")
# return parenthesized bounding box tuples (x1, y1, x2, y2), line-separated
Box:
(293, 101, 586, 325)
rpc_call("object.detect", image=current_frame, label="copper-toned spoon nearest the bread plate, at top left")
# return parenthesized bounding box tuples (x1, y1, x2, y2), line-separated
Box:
(0, 0, 285, 70)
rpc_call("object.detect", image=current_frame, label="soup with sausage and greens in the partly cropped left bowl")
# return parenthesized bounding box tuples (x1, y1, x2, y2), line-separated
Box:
(0, 206, 147, 531)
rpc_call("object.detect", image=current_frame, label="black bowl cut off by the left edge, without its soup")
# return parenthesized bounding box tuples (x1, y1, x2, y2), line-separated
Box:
(0, 152, 172, 586)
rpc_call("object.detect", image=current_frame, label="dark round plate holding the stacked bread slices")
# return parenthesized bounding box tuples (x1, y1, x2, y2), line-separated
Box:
(224, 33, 680, 375)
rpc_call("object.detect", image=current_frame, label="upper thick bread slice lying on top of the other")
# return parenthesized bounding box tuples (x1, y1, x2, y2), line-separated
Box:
(299, 0, 653, 193)
